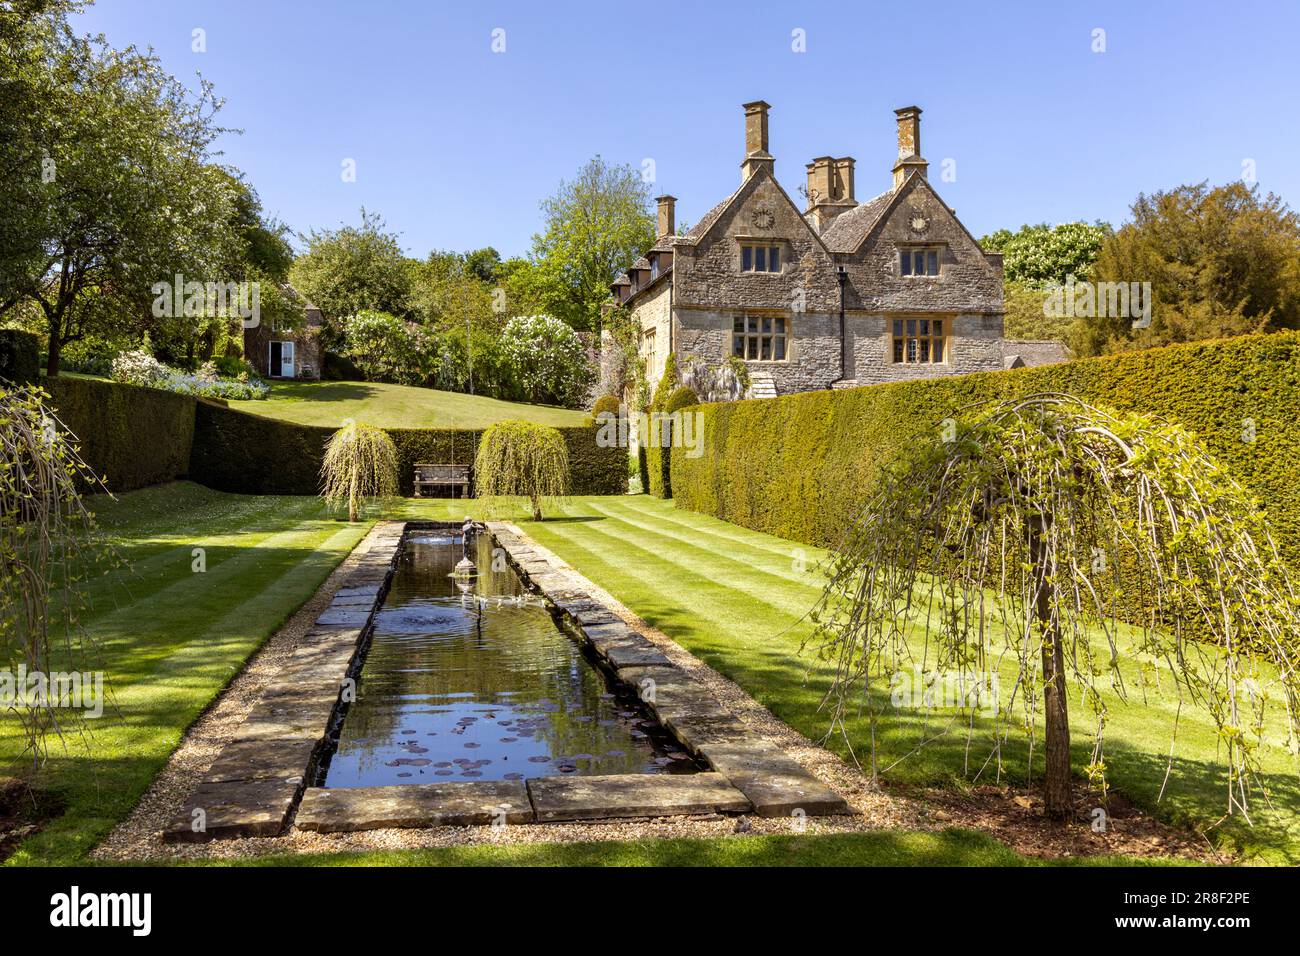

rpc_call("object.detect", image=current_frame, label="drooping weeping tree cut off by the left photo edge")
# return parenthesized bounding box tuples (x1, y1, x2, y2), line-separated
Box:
(0, 382, 117, 760)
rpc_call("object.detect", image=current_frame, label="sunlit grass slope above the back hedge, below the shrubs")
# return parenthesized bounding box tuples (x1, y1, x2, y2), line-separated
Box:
(230, 381, 586, 428)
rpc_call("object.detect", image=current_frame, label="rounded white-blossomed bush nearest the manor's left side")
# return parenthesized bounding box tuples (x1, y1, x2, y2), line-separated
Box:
(501, 315, 594, 407)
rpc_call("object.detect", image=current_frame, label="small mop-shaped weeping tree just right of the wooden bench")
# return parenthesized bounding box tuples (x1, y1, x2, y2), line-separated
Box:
(475, 421, 569, 522)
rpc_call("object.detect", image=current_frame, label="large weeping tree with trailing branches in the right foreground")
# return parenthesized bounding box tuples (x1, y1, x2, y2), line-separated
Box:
(809, 394, 1300, 819)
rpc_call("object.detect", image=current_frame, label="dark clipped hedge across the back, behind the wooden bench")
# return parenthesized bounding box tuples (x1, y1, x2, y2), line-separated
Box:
(190, 402, 627, 496)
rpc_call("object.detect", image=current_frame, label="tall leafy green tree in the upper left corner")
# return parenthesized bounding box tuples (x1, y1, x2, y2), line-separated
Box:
(0, 3, 238, 375)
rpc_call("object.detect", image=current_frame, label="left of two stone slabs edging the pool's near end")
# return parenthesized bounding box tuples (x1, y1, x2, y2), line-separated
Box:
(294, 780, 533, 834)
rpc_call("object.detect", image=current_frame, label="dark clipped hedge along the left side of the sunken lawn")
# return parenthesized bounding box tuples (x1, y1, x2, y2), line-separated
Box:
(42, 376, 195, 492)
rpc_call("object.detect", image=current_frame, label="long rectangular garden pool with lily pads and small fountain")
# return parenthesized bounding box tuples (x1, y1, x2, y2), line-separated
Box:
(317, 531, 699, 787)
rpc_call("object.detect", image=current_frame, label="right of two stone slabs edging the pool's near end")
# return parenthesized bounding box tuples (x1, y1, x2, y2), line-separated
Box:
(528, 773, 750, 823)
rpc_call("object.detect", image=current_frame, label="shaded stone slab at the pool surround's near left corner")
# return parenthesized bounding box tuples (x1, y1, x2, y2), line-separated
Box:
(163, 780, 299, 843)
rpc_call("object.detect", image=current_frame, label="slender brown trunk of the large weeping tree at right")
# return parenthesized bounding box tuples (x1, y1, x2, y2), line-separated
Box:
(1030, 519, 1073, 819)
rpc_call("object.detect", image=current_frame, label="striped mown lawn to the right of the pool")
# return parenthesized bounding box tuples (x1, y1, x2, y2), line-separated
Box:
(506, 496, 1300, 864)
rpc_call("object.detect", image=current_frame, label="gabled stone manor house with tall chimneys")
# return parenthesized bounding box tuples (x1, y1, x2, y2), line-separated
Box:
(611, 101, 1069, 397)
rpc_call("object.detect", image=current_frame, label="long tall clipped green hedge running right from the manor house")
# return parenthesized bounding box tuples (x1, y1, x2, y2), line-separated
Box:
(672, 332, 1300, 568)
